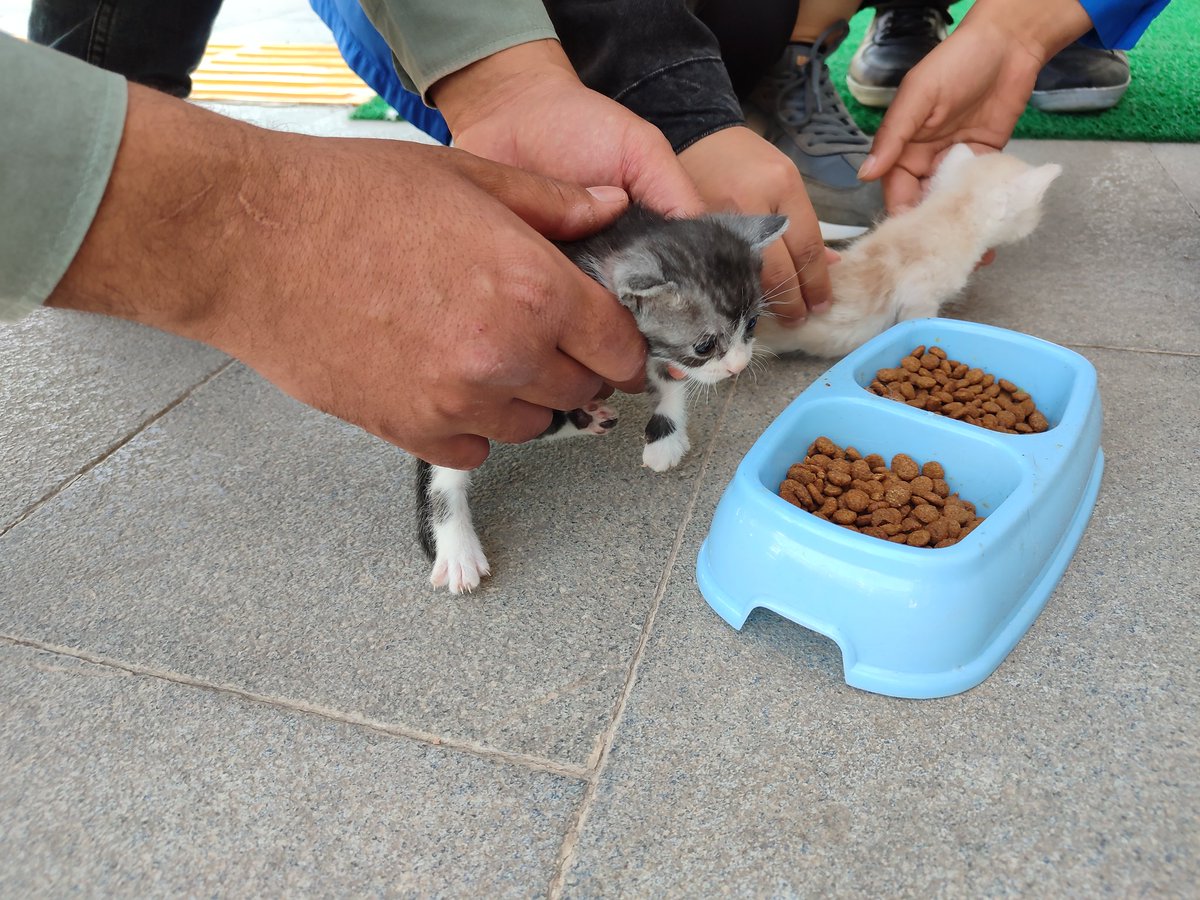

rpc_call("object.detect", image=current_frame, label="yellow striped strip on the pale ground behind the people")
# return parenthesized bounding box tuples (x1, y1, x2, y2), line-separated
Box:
(192, 43, 374, 106)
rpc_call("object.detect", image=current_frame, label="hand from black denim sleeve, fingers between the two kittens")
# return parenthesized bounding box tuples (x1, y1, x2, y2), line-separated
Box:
(679, 126, 836, 325)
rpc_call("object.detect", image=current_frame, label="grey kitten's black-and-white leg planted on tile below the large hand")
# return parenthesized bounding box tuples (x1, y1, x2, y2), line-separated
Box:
(416, 460, 491, 594)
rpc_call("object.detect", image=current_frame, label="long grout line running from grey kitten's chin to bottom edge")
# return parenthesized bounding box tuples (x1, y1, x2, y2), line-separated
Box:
(547, 383, 737, 900)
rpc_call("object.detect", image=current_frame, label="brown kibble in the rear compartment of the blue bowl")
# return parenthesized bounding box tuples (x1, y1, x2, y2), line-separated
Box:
(868, 344, 1050, 434)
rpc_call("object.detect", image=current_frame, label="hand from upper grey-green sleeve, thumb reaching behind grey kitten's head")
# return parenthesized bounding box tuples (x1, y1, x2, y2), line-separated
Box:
(430, 41, 703, 222)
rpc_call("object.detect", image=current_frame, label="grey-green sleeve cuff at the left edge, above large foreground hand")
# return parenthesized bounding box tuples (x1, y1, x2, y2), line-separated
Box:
(0, 32, 126, 320)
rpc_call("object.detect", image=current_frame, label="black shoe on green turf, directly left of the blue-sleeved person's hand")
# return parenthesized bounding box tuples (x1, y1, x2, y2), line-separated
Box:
(846, 0, 953, 109)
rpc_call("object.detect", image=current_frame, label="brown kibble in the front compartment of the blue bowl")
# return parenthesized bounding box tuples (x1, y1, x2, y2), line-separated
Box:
(779, 437, 983, 548)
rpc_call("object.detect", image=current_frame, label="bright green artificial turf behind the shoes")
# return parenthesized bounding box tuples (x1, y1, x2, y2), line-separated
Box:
(350, 0, 1200, 142)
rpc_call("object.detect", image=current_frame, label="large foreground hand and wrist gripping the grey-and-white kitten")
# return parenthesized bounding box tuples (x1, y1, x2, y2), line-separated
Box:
(49, 86, 644, 468)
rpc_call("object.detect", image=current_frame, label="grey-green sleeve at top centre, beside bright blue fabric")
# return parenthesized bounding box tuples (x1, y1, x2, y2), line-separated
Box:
(361, 0, 556, 103)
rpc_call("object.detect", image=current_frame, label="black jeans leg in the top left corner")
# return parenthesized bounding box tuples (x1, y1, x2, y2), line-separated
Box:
(29, 0, 221, 97)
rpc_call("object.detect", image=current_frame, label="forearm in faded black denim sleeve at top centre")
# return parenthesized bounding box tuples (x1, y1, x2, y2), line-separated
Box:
(546, 0, 743, 152)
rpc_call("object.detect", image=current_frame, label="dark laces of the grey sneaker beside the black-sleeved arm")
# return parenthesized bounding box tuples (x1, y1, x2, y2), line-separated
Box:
(773, 19, 871, 148)
